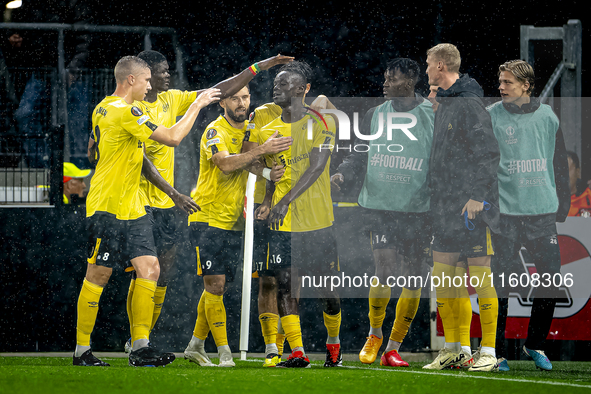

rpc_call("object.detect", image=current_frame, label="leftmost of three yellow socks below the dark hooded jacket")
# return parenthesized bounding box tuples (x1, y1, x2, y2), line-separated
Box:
(432, 262, 460, 343)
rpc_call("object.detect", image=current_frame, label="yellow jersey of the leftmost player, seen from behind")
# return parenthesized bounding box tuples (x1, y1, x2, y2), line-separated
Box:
(86, 96, 157, 220)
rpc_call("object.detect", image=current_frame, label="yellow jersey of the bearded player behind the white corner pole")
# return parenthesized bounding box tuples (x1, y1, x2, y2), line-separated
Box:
(189, 115, 248, 231)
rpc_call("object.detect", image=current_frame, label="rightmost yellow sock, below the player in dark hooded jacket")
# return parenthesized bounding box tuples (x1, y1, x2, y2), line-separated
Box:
(470, 266, 499, 348)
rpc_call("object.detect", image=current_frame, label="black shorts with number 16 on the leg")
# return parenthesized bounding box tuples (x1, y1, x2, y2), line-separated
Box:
(261, 226, 340, 276)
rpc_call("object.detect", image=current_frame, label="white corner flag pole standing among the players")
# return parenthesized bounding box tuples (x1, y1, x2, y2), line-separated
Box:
(240, 173, 256, 360)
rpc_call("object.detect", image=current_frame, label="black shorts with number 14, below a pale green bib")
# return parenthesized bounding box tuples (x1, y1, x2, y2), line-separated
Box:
(368, 210, 431, 258)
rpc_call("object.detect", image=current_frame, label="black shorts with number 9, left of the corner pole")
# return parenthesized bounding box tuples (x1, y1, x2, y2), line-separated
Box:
(196, 226, 243, 282)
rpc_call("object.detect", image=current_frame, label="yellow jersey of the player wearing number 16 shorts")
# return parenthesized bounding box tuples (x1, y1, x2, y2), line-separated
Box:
(259, 115, 336, 232)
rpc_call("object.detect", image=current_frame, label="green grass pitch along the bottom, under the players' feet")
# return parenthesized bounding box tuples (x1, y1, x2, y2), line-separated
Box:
(0, 357, 591, 394)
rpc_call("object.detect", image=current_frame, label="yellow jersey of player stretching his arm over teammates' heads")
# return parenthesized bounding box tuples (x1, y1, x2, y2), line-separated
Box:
(134, 89, 197, 208)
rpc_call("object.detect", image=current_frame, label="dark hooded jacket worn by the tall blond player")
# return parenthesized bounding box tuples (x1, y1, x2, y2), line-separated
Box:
(429, 74, 500, 232)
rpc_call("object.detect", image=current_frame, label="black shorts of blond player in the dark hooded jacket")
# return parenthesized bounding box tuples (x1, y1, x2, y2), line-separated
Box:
(431, 215, 494, 258)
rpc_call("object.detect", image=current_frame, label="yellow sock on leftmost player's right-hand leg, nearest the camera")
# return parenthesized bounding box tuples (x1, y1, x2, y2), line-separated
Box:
(131, 278, 156, 343)
